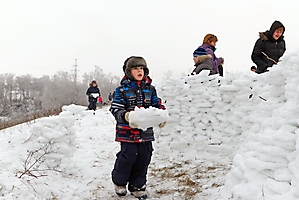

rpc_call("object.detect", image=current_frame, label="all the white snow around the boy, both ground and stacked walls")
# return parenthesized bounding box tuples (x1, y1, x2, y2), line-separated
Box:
(0, 49, 299, 200)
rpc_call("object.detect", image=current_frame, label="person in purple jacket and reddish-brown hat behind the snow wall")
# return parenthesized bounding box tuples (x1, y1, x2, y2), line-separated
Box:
(198, 34, 224, 76)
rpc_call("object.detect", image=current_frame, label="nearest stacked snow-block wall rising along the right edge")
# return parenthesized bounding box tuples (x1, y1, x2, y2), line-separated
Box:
(223, 51, 299, 200)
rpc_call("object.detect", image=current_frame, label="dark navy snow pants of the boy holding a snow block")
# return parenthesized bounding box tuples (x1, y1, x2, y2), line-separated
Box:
(112, 142, 153, 192)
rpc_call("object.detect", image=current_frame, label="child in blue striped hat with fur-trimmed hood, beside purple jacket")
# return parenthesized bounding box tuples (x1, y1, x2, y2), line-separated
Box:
(192, 48, 215, 75)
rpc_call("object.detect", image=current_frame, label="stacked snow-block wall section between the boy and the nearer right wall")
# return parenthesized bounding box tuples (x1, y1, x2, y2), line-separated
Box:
(159, 71, 262, 148)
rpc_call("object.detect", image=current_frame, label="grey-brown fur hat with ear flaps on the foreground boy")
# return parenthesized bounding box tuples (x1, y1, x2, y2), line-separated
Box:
(125, 56, 149, 80)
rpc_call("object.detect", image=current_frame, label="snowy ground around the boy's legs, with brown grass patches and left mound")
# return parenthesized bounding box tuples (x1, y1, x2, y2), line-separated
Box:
(0, 105, 231, 199)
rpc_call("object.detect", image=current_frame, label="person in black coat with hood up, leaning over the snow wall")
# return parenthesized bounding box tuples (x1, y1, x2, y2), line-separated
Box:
(251, 21, 286, 74)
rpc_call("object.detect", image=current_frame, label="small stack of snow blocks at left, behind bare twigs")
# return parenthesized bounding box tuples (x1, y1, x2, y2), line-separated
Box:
(26, 105, 78, 171)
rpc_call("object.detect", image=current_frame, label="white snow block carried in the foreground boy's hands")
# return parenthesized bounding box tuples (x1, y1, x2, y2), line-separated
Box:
(129, 107, 168, 130)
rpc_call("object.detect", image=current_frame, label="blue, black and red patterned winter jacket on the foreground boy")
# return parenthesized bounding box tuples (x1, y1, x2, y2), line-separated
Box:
(110, 77, 165, 143)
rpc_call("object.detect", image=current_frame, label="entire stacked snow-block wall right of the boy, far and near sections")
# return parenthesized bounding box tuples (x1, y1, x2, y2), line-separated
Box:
(157, 48, 299, 199)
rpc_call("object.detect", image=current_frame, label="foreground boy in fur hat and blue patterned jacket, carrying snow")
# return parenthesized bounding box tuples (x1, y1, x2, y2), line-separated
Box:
(110, 56, 166, 199)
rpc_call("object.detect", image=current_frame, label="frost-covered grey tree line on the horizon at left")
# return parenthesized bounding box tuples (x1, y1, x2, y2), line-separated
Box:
(0, 66, 120, 129)
